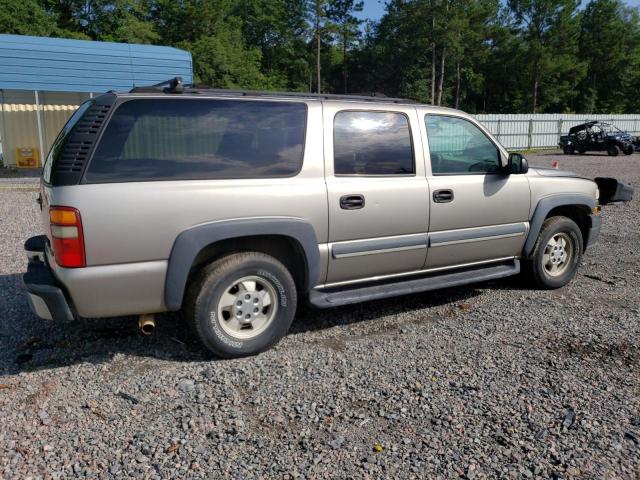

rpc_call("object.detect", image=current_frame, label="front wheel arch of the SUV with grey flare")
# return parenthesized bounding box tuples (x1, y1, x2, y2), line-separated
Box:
(522, 193, 596, 258)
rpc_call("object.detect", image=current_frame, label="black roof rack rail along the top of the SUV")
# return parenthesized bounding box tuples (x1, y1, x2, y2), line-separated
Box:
(130, 77, 416, 104)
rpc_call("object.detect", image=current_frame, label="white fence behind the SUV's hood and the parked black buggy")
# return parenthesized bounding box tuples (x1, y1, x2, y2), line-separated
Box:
(476, 113, 640, 150)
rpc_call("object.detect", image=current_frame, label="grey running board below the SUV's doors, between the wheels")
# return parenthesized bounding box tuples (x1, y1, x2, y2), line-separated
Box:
(309, 260, 520, 308)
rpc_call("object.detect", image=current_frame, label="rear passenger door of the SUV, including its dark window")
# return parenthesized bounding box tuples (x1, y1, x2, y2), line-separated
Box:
(324, 102, 429, 283)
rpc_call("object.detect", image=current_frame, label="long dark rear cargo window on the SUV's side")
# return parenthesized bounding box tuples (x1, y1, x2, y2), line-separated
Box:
(85, 99, 306, 183)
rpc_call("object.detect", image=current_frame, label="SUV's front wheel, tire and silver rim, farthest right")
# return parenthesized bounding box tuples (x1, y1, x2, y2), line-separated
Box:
(527, 217, 584, 290)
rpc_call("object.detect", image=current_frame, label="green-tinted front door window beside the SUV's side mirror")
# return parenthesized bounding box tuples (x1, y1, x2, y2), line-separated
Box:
(425, 115, 501, 175)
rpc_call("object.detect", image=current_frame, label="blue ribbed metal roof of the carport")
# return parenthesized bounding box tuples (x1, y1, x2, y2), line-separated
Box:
(0, 35, 193, 93)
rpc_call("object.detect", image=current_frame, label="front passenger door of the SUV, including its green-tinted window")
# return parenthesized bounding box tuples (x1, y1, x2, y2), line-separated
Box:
(423, 114, 531, 269)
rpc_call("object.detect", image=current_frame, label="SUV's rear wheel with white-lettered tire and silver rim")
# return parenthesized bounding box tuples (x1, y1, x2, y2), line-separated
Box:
(185, 252, 297, 358)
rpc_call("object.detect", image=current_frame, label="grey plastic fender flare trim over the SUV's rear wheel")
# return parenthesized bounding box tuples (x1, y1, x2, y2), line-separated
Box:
(164, 217, 320, 310)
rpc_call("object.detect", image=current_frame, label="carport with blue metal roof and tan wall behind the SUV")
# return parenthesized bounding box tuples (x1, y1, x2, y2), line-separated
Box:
(0, 35, 193, 166)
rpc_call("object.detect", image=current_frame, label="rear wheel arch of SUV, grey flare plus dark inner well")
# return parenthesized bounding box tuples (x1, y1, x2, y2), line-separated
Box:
(164, 217, 320, 311)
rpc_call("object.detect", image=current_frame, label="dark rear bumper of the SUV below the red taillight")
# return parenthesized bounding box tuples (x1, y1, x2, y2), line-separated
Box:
(22, 236, 74, 322)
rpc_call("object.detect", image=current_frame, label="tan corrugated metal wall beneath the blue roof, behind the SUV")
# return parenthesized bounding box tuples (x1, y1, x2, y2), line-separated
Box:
(0, 91, 89, 165)
